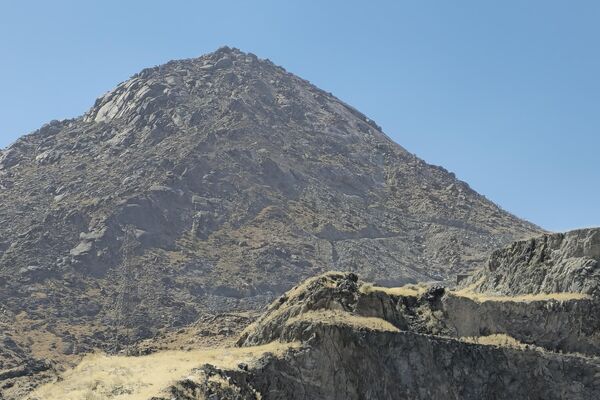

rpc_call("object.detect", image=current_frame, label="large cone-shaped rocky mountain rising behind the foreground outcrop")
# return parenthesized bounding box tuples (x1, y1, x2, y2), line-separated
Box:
(0, 47, 541, 376)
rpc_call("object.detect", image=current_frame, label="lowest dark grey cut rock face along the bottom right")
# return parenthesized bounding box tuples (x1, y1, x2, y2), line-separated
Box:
(252, 325, 600, 400)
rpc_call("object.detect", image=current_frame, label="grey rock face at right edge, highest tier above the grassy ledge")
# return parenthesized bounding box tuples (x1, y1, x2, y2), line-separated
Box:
(465, 229, 600, 296)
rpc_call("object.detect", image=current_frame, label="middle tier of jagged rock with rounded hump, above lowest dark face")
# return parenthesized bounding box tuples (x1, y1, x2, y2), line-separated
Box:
(238, 272, 600, 355)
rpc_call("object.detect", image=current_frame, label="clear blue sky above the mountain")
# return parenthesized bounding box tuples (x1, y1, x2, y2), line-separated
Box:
(0, 0, 600, 230)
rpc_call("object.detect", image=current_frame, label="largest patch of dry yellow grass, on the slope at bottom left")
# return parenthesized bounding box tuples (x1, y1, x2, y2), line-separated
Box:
(28, 342, 299, 400)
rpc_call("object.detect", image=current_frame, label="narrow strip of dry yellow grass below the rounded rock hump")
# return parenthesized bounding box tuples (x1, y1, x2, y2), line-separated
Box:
(286, 310, 399, 332)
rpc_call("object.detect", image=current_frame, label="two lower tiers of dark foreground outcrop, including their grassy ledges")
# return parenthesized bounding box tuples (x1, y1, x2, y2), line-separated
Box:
(156, 273, 600, 400)
